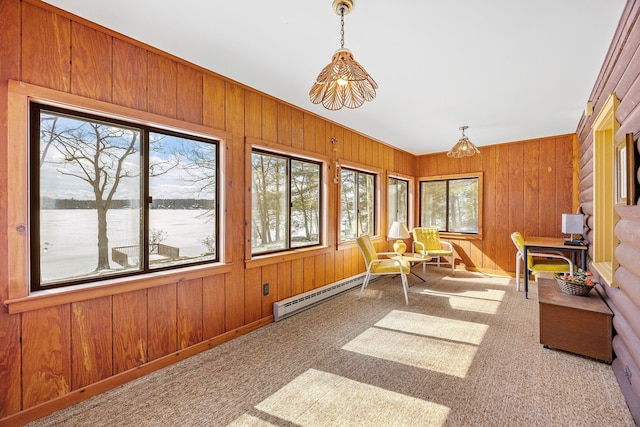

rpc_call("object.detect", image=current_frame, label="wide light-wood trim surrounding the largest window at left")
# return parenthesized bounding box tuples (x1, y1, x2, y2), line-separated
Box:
(4, 80, 232, 304)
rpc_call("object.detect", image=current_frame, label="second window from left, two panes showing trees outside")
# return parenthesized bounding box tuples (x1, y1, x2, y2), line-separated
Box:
(251, 151, 321, 254)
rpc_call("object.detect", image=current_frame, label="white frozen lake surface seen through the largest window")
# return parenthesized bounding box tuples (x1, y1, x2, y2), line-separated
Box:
(40, 209, 215, 285)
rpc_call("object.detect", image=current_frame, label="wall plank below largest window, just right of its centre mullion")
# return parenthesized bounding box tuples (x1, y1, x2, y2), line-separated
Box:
(147, 283, 178, 361)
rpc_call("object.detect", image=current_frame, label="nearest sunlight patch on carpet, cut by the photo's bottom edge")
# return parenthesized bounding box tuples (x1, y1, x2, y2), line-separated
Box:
(255, 369, 449, 427)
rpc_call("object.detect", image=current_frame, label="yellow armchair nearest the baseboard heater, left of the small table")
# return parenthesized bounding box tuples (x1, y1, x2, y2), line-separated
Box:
(356, 234, 411, 305)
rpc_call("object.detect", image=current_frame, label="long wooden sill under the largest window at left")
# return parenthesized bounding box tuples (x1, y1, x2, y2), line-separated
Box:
(4, 263, 232, 314)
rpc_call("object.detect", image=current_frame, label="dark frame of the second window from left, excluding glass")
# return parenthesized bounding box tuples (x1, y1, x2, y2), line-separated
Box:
(247, 146, 326, 254)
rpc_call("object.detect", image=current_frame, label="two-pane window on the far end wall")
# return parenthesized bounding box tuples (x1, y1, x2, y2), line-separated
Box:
(420, 176, 481, 234)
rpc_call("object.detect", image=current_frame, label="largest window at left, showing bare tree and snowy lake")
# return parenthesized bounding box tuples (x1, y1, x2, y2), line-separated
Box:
(30, 104, 218, 290)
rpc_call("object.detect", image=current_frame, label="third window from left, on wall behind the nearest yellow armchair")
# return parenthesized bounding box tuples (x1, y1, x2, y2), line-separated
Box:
(340, 169, 376, 242)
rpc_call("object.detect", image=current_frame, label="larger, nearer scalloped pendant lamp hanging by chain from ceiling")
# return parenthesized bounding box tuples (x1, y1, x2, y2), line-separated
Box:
(309, 0, 378, 110)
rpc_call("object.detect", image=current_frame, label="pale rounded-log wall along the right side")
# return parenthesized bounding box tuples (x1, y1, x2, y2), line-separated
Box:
(577, 0, 640, 424)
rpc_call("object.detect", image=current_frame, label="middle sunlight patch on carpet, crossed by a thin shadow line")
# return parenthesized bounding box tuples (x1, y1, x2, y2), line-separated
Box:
(342, 310, 488, 378)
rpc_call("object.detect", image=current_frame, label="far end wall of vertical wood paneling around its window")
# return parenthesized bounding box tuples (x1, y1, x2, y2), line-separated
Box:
(416, 134, 576, 274)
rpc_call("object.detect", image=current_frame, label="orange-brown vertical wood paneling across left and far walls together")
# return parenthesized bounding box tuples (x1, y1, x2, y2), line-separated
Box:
(0, 0, 572, 424)
